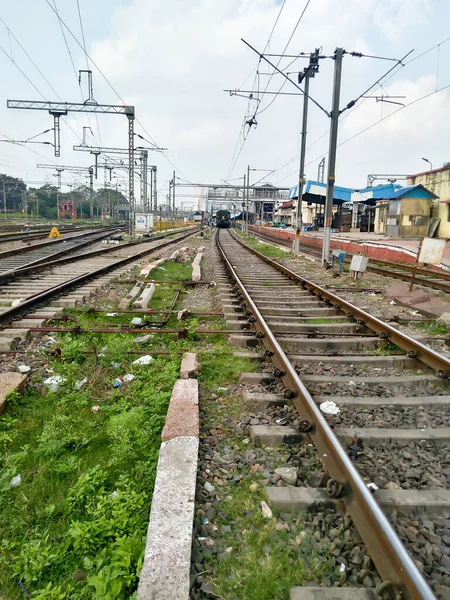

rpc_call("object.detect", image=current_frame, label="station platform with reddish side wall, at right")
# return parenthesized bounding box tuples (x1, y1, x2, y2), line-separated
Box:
(250, 226, 450, 270)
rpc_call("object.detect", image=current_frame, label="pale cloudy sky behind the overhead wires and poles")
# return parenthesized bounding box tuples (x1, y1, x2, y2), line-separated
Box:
(0, 0, 450, 206)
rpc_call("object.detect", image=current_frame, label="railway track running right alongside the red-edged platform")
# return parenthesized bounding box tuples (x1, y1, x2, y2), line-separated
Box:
(252, 230, 450, 293)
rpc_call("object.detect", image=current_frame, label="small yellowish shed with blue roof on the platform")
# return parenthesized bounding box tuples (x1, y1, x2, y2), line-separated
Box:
(375, 184, 436, 237)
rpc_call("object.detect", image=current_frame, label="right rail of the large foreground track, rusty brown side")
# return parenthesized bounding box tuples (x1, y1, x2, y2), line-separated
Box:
(241, 233, 450, 377)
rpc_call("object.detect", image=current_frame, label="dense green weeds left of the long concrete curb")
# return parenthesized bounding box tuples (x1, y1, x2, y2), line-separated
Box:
(0, 334, 180, 600)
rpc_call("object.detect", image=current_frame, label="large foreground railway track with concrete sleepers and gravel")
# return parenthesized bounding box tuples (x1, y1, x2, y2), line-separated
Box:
(216, 230, 450, 599)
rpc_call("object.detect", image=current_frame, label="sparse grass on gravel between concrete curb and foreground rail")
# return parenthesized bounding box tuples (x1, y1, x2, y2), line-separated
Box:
(194, 352, 339, 600)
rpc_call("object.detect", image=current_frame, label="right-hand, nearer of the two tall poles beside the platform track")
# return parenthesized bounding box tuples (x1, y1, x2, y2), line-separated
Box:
(322, 48, 344, 266)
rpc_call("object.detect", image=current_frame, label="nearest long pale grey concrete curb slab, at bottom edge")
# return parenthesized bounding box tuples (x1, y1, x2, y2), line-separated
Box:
(137, 437, 199, 600)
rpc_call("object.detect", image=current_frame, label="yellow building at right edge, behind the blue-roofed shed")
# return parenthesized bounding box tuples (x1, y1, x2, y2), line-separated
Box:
(408, 163, 450, 239)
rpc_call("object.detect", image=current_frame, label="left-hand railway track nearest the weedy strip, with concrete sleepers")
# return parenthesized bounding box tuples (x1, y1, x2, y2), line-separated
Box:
(0, 228, 197, 344)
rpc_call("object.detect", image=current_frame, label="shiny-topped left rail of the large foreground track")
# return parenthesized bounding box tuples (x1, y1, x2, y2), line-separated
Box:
(216, 230, 435, 600)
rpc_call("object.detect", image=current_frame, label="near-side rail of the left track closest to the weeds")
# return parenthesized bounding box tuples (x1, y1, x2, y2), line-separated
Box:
(0, 231, 195, 328)
